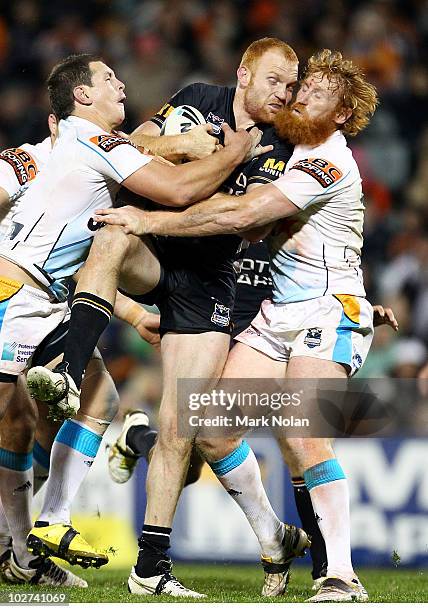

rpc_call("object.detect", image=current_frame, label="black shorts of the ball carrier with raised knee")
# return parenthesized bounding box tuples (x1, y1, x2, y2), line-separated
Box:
(122, 238, 236, 336)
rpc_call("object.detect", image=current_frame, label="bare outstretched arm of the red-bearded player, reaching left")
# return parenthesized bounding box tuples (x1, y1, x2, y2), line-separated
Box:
(95, 185, 299, 236)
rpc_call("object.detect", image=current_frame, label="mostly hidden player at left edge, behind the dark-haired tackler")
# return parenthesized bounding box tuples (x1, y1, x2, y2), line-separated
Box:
(0, 114, 87, 587)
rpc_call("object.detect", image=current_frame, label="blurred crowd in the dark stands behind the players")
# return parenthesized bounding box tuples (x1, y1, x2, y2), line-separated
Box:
(0, 0, 428, 416)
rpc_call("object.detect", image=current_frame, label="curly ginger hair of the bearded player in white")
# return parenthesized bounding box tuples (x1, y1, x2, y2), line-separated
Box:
(304, 49, 379, 136)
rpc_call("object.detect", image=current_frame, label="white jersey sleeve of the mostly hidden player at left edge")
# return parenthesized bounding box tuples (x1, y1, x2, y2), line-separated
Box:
(0, 147, 39, 199)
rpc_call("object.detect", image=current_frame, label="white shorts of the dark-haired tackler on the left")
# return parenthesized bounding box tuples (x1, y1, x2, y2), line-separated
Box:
(0, 276, 68, 374)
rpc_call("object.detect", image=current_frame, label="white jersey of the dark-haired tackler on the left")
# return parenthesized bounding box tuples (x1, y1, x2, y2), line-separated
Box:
(0, 116, 153, 287)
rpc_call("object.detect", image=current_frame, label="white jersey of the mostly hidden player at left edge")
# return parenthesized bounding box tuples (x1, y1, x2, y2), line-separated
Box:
(0, 137, 52, 240)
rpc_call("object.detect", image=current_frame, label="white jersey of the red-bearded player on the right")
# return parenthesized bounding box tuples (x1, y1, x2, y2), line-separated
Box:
(269, 130, 365, 303)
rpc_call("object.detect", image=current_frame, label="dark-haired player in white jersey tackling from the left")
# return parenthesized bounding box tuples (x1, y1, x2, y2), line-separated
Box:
(0, 55, 266, 592)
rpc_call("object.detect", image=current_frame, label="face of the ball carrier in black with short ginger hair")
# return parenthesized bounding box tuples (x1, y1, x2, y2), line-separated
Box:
(244, 50, 298, 123)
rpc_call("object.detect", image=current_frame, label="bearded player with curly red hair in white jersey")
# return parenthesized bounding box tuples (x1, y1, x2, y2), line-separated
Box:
(96, 50, 377, 602)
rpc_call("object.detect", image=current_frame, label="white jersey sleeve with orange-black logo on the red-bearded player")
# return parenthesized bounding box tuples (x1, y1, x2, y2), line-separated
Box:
(273, 157, 346, 209)
